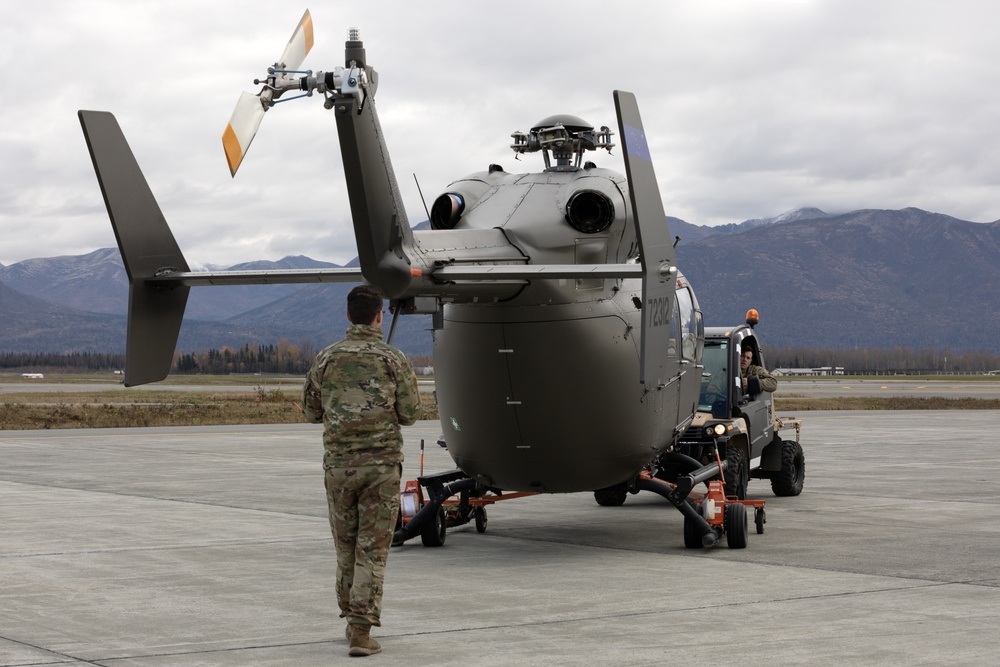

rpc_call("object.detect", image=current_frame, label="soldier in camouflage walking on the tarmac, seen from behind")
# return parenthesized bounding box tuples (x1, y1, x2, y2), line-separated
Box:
(302, 285, 420, 656)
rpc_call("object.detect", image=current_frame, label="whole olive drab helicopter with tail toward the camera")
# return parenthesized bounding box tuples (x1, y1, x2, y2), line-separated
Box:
(79, 11, 752, 544)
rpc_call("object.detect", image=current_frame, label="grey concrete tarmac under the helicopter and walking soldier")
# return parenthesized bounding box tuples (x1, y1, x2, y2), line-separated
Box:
(0, 411, 1000, 667)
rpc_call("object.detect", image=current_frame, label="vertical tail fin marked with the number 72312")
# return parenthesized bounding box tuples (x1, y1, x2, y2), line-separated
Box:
(614, 90, 677, 390)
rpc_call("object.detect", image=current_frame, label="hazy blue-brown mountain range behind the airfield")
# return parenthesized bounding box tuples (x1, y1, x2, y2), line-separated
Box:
(0, 208, 1000, 355)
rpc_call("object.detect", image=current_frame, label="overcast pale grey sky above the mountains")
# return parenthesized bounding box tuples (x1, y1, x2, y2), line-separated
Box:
(0, 0, 1000, 267)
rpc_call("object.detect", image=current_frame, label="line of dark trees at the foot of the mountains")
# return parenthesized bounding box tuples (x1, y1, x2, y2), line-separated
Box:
(0, 338, 1000, 375)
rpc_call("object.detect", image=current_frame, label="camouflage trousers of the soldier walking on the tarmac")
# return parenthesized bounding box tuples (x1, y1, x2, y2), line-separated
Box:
(325, 465, 402, 626)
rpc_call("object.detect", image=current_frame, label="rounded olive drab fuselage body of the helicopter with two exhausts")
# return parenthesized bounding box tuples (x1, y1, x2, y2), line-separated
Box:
(430, 168, 700, 493)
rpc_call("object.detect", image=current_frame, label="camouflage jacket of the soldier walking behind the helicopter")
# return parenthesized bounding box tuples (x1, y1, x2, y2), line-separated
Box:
(302, 324, 420, 468)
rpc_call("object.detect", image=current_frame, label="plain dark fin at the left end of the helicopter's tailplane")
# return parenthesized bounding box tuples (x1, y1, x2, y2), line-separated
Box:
(79, 111, 191, 387)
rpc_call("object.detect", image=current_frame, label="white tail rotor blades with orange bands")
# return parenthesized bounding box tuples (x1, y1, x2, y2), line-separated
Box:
(222, 9, 313, 177)
